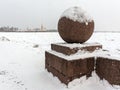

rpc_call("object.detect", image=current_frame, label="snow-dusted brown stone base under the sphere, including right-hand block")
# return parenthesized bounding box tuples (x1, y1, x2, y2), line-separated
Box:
(45, 43, 120, 85)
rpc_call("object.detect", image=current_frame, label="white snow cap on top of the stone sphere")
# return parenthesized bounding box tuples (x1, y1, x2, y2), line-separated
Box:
(61, 7, 93, 23)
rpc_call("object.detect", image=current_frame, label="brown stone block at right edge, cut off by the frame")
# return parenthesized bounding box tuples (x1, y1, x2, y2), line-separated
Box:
(96, 57, 120, 85)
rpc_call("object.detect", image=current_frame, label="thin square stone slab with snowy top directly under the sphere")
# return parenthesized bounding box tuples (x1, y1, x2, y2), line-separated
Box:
(51, 43, 102, 55)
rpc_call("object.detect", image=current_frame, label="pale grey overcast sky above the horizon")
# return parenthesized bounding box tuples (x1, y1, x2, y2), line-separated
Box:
(0, 0, 120, 30)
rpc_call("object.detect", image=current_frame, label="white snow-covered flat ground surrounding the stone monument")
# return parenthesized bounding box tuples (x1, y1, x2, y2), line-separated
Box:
(0, 32, 120, 90)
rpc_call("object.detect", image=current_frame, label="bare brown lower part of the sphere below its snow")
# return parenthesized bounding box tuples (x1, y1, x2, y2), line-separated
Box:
(58, 17, 94, 43)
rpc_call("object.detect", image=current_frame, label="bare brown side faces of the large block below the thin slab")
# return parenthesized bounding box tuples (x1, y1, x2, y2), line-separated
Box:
(45, 52, 94, 84)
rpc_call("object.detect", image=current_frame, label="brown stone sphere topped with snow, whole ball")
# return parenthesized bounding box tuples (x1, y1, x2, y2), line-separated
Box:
(58, 7, 94, 43)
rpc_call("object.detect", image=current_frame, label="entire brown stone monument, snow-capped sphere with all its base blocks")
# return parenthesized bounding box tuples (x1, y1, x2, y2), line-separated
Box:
(45, 7, 120, 85)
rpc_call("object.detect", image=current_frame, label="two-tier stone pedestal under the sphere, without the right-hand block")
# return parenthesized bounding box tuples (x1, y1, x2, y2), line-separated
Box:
(45, 43, 102, 85)
